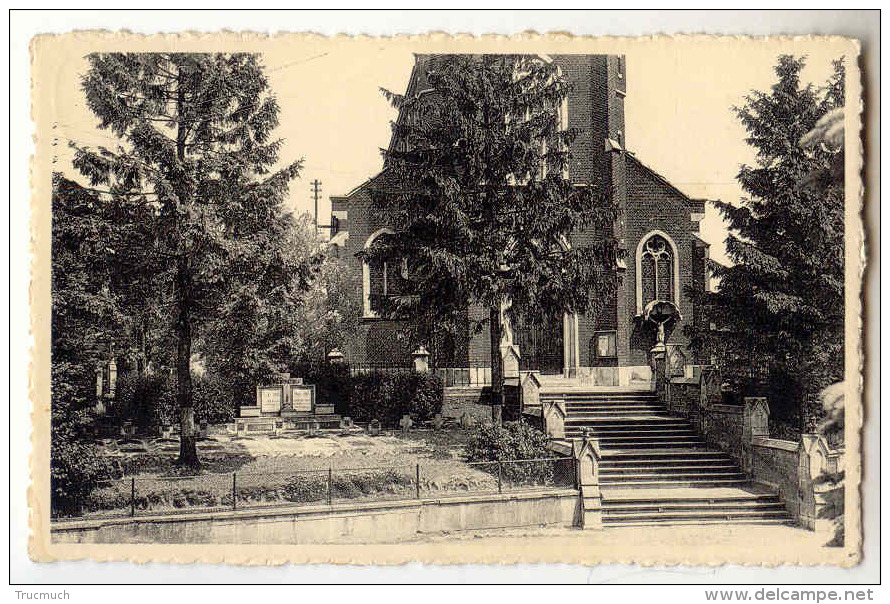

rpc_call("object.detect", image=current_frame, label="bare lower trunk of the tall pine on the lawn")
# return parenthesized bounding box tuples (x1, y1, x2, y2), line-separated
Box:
(176, 258, 201, 468)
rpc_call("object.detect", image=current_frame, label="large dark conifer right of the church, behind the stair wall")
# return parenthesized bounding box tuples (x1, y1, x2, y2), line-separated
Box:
(690, 55, 844, 428)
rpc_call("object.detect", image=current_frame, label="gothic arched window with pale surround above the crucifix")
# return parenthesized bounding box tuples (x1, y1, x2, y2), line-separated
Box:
(637, 232, 680, 314)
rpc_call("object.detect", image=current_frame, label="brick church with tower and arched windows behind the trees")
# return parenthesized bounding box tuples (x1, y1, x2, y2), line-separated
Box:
(330, 55, 708, 386)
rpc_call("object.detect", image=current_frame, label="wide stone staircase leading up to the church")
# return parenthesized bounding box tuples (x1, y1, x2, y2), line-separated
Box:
(559, 389, 792, 527)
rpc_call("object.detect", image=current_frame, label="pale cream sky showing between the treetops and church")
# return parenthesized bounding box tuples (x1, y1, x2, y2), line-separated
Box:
(51, 38, 835, 262)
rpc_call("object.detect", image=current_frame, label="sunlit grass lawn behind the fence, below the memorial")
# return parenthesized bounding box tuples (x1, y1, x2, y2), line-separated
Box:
(81, 429, 520, 516)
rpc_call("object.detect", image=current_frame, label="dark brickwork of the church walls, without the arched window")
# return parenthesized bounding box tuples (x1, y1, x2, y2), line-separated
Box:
(332, 55, 704, 367)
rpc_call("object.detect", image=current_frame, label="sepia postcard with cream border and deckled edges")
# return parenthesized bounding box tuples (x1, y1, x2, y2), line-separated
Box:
(29, 31, 865, 566)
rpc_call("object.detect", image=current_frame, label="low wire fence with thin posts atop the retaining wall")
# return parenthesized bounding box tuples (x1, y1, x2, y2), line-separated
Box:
(54, 458, 577, 520)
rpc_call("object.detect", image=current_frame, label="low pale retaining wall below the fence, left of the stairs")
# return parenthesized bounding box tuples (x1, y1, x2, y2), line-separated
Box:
(50, 490, 581, 545)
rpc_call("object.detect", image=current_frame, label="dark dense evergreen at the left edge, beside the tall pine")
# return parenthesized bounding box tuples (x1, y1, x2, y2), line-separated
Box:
(50, 174, 126, 514)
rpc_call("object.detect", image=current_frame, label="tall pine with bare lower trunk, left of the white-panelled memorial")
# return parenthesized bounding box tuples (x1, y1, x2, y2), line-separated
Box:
(74, 53, 300, 466)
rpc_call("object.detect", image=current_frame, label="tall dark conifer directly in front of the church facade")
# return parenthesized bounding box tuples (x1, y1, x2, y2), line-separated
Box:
(368, 55, 617, 420)
